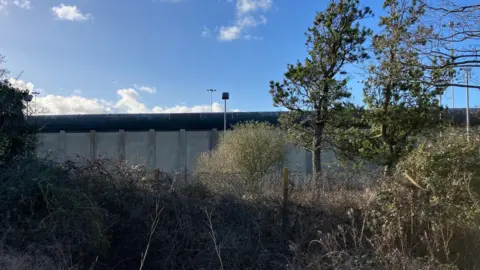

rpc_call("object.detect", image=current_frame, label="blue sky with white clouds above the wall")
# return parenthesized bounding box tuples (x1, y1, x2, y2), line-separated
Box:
(0, 0, 480, 113)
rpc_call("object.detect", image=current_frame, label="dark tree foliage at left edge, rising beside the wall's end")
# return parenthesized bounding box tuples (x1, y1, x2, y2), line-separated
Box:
(0, 80, 36, 167)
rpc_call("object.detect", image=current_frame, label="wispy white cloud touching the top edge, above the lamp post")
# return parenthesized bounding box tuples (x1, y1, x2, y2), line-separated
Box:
(218, 0, 273, 41)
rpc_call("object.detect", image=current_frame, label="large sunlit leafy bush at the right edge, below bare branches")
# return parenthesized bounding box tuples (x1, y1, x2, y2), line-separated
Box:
(373, 131, 480, 269)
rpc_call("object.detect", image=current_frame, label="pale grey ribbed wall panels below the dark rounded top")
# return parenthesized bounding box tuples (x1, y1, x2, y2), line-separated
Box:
(38, 129, 333, 173)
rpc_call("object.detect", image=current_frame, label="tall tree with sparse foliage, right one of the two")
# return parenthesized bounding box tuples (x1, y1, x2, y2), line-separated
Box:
(353, 0, 442, 174)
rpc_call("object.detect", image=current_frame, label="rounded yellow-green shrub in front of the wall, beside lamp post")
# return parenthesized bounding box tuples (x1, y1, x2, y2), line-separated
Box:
(197, 122, 286, 189)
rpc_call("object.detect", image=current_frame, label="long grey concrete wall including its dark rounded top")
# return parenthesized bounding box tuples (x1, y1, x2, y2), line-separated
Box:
(28, 108, 480, 173)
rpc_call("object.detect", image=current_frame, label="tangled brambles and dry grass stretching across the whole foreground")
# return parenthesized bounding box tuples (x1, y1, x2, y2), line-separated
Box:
(0, 130, 478, 270)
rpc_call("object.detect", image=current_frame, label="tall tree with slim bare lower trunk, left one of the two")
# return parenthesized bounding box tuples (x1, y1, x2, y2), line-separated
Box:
(270, 0, 372, 177)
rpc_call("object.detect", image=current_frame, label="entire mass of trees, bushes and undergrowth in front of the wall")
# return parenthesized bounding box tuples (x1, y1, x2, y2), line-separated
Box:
(0, 0, 480, 270)
